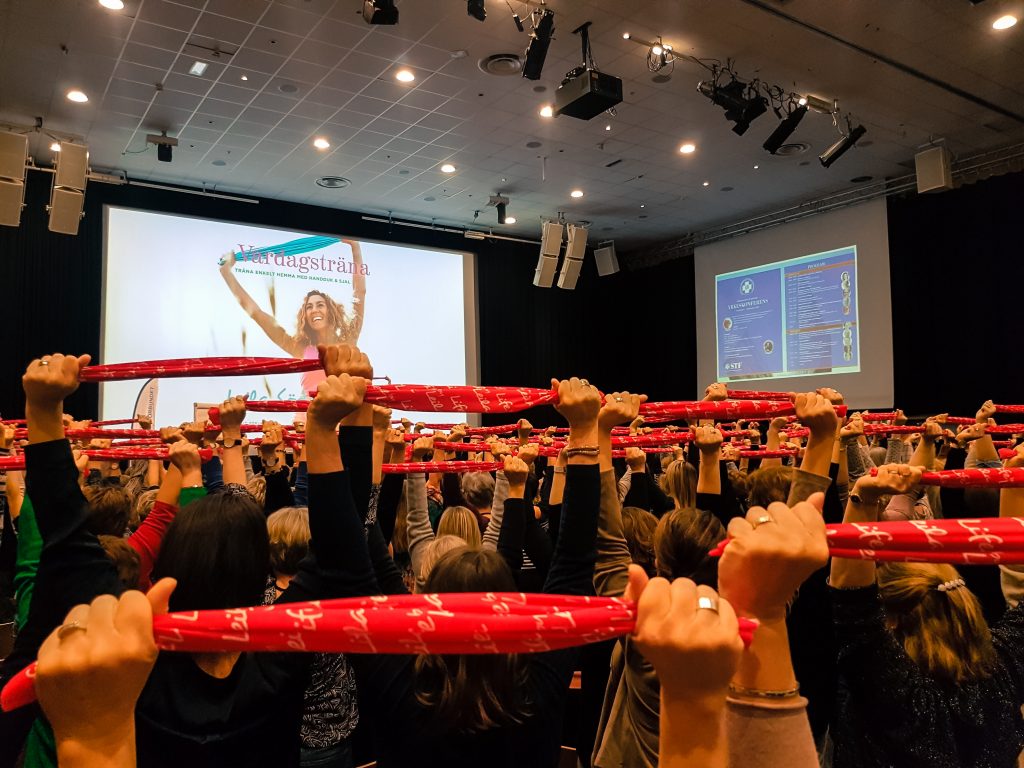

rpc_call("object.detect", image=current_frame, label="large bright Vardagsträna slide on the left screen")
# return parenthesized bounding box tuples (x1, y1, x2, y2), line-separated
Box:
(97, 207, 479, 425)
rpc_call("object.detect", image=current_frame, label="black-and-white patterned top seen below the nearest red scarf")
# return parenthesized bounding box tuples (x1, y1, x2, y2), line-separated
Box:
(263, 577, 359, 750)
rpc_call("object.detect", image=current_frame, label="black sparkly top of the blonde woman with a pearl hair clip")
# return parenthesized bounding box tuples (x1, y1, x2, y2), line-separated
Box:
(830, 585, 1024, 768)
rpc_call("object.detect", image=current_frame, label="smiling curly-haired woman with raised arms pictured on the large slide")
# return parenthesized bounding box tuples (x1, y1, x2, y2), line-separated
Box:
(220, 240, 367, 392)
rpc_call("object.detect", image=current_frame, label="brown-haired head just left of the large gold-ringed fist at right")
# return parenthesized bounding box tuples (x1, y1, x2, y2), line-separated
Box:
(654, 508, 725, 589)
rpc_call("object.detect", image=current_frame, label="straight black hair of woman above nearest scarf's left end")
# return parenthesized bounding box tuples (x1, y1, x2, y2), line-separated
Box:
(153, 493, 270, 610)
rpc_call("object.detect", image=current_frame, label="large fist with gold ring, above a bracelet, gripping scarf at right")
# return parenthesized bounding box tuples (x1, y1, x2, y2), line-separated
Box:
(718, 494, 828, 622)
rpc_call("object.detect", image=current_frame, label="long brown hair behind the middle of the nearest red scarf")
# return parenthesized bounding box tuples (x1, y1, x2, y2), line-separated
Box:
(414, 547, 529, 733)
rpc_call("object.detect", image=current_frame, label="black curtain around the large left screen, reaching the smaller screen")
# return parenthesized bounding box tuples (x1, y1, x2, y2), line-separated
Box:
(0, 173, 696, 424)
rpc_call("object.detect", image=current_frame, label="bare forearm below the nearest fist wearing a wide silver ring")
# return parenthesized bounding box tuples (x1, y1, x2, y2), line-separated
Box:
(657, 688, 729, 768)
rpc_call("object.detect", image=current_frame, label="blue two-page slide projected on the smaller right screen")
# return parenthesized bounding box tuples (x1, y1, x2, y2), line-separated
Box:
(715, 245, 860, 382)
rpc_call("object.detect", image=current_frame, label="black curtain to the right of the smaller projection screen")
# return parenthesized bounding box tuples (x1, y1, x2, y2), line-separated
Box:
(889, 173, 1024, 416)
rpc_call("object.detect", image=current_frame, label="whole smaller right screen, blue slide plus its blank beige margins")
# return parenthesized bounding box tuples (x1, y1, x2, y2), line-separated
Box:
(693, 200, 893, 409)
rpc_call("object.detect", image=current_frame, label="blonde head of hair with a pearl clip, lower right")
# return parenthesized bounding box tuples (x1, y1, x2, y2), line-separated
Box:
(878, 562, 996, 683)
